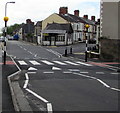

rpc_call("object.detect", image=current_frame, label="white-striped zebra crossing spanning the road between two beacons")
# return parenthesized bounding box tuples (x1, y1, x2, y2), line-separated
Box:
(17, 60, 93, 66)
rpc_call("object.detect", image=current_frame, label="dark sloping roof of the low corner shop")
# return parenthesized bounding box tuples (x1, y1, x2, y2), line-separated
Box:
(42, 23, 73, 33)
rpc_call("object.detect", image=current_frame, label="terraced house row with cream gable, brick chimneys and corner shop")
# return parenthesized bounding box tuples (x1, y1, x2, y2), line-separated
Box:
(40, 7, 99, 45)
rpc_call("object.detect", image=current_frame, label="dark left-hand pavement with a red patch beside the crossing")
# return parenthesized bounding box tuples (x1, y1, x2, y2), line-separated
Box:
(0, 57, 17, 113)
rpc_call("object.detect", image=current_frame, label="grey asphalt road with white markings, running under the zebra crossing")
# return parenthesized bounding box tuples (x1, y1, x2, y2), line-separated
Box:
(7, 41, 120, 111)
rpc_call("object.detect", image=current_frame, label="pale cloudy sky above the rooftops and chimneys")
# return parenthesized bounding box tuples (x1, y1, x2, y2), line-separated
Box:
(0, 0, 100, 32)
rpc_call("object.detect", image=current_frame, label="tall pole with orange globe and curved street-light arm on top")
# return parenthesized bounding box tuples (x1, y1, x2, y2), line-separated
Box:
(4, 2, 15, 65)
